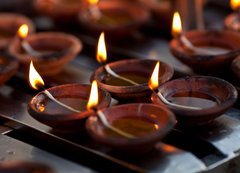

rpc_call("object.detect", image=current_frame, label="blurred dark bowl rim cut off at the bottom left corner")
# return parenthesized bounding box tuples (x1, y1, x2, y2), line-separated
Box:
(0, 161, 55, 173)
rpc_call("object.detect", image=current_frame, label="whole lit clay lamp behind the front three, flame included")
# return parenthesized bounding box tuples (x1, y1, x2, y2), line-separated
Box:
(91, 33, 173, 102)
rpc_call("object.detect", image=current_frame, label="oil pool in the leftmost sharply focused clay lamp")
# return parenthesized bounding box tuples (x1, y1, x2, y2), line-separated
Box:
(37, 97, 87, 115)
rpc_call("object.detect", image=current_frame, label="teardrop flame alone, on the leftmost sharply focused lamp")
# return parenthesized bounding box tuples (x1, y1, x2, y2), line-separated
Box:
(29, 61, 44, 90)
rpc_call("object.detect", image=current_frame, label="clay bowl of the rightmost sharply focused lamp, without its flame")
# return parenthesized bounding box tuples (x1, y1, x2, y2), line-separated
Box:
(152, 76, 237, 126)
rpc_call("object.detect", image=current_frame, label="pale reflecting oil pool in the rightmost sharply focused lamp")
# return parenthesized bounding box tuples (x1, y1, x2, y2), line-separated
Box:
(167, 92, 219, 108)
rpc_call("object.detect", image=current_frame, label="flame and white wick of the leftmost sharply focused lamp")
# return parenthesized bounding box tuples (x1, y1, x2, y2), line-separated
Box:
(29, 61, 80, 113)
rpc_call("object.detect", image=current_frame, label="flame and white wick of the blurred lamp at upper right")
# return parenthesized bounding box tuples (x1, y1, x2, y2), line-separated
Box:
(172, 12, 216, 55)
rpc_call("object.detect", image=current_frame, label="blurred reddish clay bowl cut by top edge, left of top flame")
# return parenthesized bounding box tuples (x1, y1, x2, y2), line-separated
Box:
(34, 0, 84, 22)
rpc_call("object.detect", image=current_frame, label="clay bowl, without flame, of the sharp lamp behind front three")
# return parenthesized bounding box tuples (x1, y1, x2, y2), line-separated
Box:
(91, 59, 174, 102)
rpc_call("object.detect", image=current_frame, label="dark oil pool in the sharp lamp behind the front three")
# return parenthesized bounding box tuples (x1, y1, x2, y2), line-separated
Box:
(104, 72, 149, 86)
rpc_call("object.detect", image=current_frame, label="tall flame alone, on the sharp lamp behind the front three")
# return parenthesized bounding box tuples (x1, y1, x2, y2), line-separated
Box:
(96, 32, 107, 64)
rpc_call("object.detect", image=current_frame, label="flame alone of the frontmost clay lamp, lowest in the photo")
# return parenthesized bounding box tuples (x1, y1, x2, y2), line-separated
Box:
(87, 80, 98, 110)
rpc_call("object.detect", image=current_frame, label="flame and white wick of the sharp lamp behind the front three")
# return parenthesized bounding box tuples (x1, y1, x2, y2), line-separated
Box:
(96, 32, 138, 85)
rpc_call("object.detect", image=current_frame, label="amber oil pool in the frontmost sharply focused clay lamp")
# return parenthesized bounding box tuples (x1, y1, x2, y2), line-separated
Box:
(105, 116, 159, 137)
